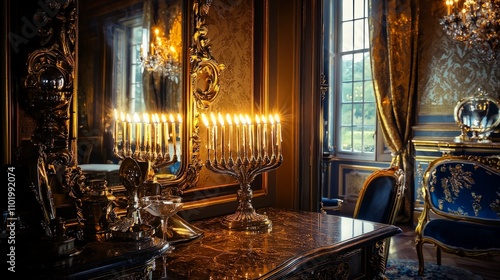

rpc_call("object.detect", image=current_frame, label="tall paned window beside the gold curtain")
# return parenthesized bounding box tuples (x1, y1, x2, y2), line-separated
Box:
(324, 0, 377, 160)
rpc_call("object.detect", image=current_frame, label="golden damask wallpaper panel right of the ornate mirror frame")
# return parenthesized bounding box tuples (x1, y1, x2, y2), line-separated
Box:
(192, 0, 254, 187)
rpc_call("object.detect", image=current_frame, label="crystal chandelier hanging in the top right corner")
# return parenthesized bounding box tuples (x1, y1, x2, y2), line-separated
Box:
(439, 0, 500, 60)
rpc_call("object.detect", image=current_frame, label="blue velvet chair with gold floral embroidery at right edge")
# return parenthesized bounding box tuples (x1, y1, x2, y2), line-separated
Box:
(415, 155, 500, 275)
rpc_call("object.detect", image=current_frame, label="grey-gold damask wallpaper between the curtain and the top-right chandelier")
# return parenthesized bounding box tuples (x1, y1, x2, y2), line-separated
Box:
(418, 0, 500, 116)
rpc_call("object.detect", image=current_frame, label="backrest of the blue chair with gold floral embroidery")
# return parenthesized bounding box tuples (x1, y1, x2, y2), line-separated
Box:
(423, 156, 500, 223)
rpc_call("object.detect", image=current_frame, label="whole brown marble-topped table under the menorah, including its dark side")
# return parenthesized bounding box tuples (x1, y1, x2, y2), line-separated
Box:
(159, 208, 401, 280)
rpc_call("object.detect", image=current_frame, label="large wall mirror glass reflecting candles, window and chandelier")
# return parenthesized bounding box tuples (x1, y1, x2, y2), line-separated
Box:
(77, 0, 191, 185)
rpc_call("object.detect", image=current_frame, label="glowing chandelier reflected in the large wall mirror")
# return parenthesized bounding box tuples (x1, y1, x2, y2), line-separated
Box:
(139, 28, 180, 78)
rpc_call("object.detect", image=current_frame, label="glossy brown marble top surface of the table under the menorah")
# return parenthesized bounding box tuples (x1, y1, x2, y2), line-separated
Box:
(157, 208, 401, 279)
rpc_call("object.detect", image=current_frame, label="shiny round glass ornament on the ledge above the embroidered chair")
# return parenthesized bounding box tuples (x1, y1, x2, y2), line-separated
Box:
(454, 89, 500, 143)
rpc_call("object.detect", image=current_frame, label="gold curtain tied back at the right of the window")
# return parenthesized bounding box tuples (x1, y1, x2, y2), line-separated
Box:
(369, 0, 419, 221)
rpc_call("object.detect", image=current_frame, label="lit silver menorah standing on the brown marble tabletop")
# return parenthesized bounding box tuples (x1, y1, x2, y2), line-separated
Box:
(202, 113, 283, 231)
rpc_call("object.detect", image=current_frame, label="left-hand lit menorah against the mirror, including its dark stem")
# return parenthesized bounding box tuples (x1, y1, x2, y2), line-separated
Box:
(113, 110, 182, 239)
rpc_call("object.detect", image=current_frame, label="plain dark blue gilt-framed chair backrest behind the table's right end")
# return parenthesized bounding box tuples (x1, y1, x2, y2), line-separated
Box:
(353, 167, 406, 224)
